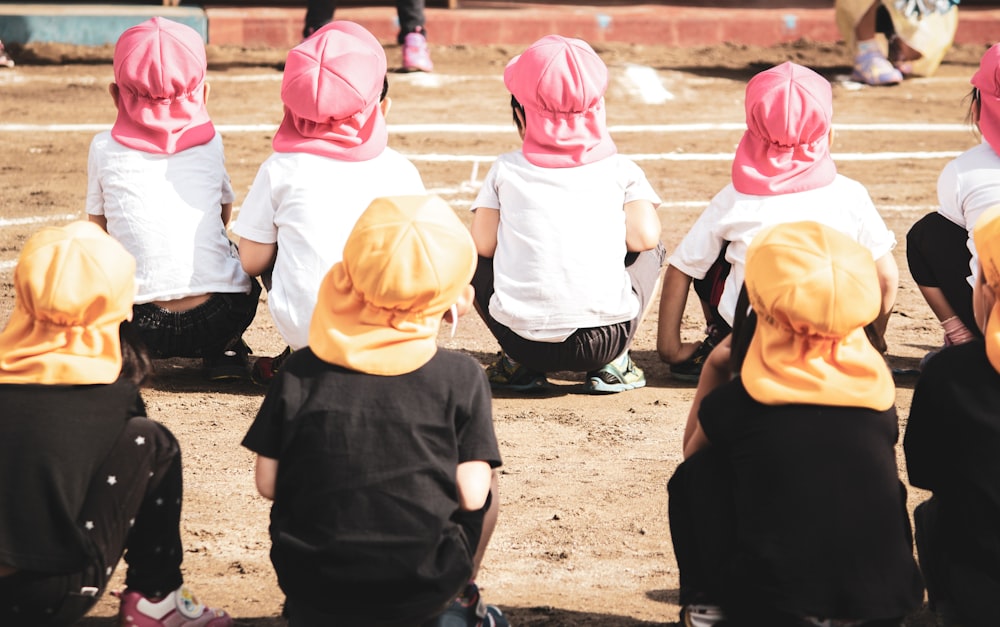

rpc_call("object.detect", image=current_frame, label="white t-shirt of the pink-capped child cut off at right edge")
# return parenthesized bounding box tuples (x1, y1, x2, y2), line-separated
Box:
(938, 142, 1000, 285)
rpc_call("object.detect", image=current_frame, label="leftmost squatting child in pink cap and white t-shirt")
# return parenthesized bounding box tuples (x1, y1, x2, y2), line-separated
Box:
(87, 17, 260, 380)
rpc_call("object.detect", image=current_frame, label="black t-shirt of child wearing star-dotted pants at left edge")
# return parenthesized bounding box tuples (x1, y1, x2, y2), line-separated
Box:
(0, 380, 146, 573)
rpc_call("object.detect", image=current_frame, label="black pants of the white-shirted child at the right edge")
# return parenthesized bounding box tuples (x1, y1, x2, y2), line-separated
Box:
(906, 212, 982, 337)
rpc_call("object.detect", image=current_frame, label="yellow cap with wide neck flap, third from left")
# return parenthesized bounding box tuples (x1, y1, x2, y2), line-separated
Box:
(741, 222, 896, 411)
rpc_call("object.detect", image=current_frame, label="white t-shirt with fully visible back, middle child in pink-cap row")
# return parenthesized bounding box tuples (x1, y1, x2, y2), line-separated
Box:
(472, 151, 660, 342)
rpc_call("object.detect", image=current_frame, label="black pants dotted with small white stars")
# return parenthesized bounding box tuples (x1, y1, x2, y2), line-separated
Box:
(0, 418, 183, 627)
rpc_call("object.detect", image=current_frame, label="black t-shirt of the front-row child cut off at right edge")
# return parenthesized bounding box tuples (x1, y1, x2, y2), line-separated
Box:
(903, 340, 1000, 625)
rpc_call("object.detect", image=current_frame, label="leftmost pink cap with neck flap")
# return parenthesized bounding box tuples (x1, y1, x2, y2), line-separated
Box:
(111, 17, 215, 154)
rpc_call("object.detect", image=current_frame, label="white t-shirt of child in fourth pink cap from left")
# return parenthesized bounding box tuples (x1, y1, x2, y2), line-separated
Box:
(669, 174, 896, 324)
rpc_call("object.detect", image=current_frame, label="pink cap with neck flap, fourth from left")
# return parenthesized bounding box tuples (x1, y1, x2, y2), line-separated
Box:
(732, 61, 837, 196)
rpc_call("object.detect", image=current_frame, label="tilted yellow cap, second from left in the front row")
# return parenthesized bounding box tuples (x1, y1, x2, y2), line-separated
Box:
(309, 195, 477, 375)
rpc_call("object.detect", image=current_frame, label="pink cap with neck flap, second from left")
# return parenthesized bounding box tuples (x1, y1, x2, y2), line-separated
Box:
(272, 20, 389, 161)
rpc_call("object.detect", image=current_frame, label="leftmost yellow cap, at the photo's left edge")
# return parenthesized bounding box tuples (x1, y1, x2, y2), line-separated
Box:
(0, 222, 135, 385)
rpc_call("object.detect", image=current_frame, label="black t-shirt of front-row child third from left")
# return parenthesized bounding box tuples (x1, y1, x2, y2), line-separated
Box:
(699, 379, 923, 620)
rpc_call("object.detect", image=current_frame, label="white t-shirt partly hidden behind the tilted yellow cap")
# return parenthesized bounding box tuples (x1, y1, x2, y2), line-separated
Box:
(233, 148, 425, 350)
